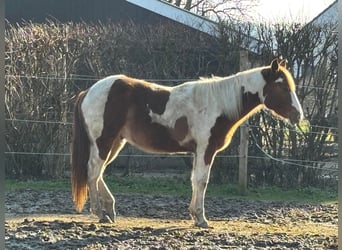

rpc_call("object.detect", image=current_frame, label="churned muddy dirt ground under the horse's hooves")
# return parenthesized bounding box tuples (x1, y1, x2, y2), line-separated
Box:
(5, 190, 338, 249)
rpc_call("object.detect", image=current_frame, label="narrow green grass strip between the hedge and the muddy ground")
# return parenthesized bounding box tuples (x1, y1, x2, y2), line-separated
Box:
(5, 176, 337, 203)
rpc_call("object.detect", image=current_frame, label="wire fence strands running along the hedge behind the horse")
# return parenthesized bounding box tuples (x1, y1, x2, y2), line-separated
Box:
(5, 74, 338, 178)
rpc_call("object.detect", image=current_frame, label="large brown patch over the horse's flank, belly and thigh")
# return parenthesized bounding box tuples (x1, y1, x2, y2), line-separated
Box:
(96, 77, 193, 160)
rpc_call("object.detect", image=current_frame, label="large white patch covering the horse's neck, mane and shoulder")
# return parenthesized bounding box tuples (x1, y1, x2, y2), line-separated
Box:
(149, 67, 266, 148)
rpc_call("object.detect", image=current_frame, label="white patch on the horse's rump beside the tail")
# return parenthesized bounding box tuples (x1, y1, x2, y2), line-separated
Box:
(81, 75, 125, 143)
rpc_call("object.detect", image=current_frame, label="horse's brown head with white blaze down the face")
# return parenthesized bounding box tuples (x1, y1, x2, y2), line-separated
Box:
(262, 59, 303, 124)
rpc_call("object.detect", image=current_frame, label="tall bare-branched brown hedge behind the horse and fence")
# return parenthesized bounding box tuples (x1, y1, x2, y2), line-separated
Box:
(5, 21, 337, 189)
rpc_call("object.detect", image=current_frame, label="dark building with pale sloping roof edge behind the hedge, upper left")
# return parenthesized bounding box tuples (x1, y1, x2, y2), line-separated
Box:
(5, 0, 260, 54)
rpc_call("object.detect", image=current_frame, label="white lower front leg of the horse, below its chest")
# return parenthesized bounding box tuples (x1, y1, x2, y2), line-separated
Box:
(189, 155, 211, 228)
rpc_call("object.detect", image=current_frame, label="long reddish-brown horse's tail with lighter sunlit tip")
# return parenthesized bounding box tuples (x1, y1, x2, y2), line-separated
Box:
(71, 91, 90, 212)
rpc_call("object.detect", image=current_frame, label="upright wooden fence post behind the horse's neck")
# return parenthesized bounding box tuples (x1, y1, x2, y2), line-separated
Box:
(239, 50, 249, 195)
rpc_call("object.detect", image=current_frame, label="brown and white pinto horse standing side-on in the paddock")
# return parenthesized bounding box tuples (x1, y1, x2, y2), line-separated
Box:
(72, 59, 303, 227)
